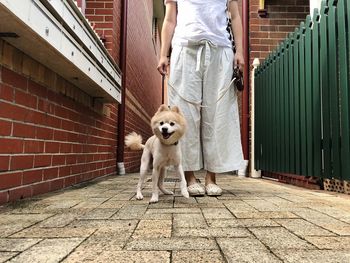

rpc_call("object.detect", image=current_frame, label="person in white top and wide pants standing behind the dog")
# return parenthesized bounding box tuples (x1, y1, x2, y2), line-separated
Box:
(158, 0, 244, 196)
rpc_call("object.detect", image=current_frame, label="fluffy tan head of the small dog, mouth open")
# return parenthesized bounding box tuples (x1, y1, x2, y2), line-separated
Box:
(151, 105, 186, 145)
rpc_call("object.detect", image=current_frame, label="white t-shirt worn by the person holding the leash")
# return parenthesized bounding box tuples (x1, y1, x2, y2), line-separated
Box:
(164, 0, 232, 47)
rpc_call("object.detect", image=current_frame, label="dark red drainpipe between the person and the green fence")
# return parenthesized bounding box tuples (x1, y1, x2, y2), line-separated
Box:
(242, 0, 250, 163)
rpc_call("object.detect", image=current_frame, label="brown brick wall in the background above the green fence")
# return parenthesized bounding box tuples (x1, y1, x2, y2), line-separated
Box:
(249, 0, 309, 64)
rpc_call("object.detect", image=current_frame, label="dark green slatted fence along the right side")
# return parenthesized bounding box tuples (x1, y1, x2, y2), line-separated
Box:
(254, 0, 350, 180)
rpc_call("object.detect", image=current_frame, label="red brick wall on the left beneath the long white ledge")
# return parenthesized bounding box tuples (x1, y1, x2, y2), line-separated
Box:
(0, 40, 117, 204)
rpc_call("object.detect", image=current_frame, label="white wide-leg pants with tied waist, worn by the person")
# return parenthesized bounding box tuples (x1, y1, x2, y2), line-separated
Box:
(168, 41, 245, 173)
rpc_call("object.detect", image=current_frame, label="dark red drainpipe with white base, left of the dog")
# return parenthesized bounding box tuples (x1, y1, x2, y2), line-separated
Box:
(117, 0, 128, 175)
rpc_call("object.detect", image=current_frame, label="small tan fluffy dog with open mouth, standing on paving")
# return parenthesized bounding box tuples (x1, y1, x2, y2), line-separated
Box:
(125, 105, 189, 203)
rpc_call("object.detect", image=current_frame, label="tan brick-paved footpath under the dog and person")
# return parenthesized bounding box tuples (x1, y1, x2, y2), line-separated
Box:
(0, 174, 350, 263)
